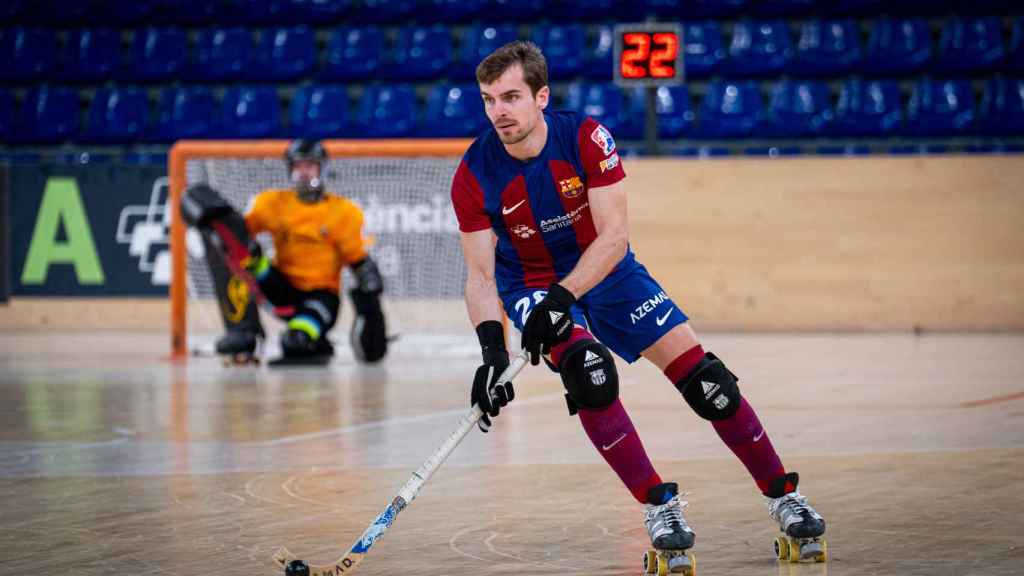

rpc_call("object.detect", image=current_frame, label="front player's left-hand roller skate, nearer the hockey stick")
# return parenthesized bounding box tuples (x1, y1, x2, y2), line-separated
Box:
(643, 482, 697, 576)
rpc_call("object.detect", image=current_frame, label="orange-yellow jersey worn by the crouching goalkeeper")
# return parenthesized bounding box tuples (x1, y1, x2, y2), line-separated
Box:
(246, 190, 367, 293)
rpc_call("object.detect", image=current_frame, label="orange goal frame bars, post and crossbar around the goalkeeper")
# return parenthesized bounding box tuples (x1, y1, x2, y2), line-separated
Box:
(167, 138, 472, 360)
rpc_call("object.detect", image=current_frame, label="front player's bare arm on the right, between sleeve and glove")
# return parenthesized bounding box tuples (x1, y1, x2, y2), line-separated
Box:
(558, 181, 629, 299)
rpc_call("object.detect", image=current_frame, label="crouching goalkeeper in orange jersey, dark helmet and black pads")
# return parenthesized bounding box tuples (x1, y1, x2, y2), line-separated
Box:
(182, 139, 387, 364)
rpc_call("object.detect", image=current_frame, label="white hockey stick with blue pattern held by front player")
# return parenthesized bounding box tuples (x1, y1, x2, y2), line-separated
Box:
(273, 351, 528, 576)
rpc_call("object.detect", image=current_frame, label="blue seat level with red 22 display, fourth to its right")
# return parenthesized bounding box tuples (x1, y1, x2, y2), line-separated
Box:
(861, 17, 932, 75)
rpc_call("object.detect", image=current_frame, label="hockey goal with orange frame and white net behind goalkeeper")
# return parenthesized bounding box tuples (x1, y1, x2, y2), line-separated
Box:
(168, 139, 471, 358)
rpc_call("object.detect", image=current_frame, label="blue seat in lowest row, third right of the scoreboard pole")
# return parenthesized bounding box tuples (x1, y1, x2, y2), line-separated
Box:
(762, 80, 836, 137)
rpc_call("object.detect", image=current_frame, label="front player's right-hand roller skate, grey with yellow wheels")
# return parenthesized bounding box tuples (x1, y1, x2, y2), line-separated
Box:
(765, 472, 828, 563)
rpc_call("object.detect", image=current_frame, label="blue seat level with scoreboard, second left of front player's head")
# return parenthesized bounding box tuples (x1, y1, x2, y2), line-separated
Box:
(384, 26, 452, 81)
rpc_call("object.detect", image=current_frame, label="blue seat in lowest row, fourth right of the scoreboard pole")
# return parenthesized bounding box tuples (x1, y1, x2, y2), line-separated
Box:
(834, 78, 903, 136)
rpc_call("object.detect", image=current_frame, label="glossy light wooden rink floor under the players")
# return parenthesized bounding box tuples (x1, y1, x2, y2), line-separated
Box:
(0, 333, 1024, 576)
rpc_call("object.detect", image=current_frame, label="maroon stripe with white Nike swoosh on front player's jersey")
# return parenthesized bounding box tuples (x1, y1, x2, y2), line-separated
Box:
(500, 174, 557, 288)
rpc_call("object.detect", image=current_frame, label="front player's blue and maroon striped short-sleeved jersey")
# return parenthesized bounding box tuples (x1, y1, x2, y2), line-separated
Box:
(452, 112, 636, 294)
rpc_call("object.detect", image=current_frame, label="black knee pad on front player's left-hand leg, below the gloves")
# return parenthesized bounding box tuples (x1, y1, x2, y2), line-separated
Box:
(558, 339, 618, 414)
